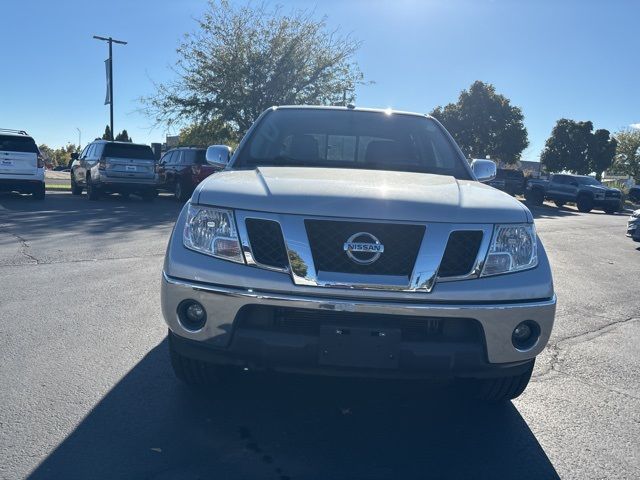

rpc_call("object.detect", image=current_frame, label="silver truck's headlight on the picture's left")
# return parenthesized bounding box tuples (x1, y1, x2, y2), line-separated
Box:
(182, 204, 244, 263)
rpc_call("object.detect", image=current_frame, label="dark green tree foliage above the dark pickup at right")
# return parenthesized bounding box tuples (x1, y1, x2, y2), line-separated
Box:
(540, 118, 616, 179)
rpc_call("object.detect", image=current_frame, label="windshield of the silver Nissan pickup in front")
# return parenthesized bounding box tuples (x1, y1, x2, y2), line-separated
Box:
(234, 109, 470, 179)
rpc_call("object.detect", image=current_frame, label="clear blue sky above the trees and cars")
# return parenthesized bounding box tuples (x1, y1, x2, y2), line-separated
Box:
(0, 0, 640, 160)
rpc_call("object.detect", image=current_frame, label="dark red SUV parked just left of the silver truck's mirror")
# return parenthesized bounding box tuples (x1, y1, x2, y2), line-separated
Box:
(158, 147, 221, 201)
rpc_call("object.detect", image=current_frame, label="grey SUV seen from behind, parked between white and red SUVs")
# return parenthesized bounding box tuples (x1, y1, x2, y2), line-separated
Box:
(71, 140, 158, 200)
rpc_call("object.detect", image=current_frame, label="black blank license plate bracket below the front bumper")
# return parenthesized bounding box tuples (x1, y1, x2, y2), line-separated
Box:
(319, 325, 400, 369)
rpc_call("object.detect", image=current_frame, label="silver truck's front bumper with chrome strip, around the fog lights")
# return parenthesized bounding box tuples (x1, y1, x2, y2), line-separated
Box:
(161, 273, 556, 370)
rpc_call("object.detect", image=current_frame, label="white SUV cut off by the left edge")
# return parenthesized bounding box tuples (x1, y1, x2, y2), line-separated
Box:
(0, 128, 45, 200)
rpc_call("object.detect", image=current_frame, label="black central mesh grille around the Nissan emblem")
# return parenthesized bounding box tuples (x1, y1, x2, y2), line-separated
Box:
(305, 220, 425, 278)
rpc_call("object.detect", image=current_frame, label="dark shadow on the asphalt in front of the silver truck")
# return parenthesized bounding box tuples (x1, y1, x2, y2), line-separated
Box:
(30, 340, 558, 480)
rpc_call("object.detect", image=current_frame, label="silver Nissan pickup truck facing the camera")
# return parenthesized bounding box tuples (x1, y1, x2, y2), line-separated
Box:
(162, 107, 556, 401)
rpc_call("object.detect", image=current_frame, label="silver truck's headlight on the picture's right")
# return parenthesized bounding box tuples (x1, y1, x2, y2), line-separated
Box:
(482, 223, 538, 276)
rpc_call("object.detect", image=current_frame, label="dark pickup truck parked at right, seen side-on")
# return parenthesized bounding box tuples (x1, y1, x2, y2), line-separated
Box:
(525, 174, 622, 214)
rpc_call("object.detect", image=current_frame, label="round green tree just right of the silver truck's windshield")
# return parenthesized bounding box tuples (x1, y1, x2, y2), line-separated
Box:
(431, 80, 529, 164)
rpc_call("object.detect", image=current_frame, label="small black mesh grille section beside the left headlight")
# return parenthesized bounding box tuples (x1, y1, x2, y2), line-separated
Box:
(245, 218, 289, 268)
